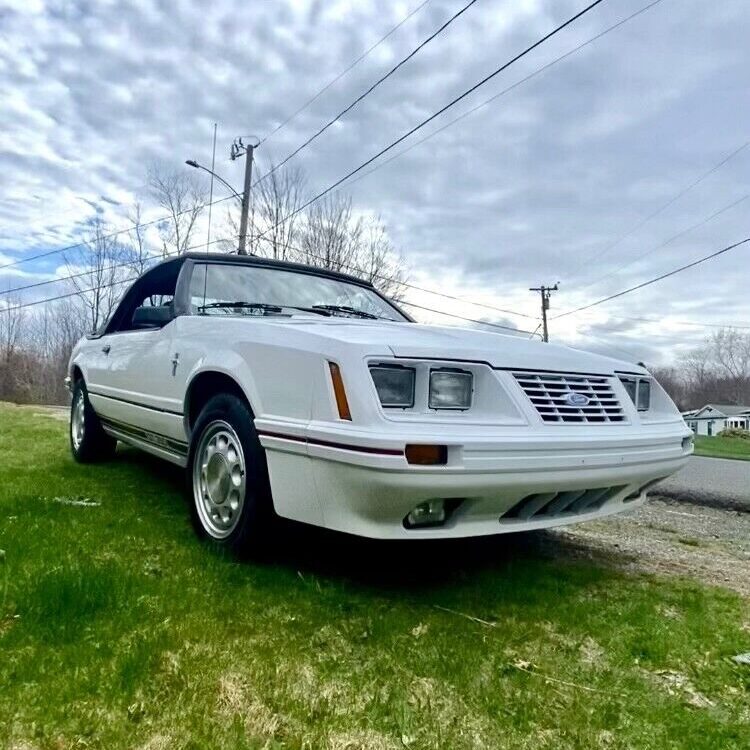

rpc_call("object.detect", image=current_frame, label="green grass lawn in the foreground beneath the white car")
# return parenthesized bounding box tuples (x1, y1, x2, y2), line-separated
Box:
(0, 406, 750, 750)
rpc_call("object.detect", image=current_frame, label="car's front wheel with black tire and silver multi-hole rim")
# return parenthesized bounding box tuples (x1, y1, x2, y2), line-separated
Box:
(187, 393, 276, 557)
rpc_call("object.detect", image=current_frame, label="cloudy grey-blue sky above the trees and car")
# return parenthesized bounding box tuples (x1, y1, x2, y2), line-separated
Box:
(0, 0, 750, 364)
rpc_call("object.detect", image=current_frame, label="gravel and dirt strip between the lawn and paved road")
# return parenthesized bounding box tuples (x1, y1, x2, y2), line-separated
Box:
(541, 498, 750, 597)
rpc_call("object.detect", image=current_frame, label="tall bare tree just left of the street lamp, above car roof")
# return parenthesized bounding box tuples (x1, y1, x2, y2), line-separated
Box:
(148, 165, 207, 256)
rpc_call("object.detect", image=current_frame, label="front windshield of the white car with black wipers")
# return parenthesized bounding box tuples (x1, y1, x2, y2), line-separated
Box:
(190, 263, 406, 321)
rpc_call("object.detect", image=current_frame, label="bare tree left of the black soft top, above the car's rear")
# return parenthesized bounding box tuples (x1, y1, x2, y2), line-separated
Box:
(63, 218, 132, 331)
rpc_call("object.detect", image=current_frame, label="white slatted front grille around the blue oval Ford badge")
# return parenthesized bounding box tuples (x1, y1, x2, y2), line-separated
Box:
(513, 372, 626, 424)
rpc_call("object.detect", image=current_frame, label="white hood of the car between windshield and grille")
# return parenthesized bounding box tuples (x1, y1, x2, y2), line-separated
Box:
(266, 317, 645, 374)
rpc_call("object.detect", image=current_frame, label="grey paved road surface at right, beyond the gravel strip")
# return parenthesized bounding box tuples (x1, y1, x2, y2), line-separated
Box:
(653, 456, 750, 512)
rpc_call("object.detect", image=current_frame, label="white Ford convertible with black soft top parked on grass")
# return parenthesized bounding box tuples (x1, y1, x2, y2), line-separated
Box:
(69, 254, 692, 550)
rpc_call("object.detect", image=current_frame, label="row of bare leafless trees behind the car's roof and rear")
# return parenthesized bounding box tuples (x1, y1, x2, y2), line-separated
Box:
(0, 159, 408, 403)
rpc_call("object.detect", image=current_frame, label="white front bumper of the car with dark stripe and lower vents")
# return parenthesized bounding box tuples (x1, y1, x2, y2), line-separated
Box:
(258, 423, 692, 539)
